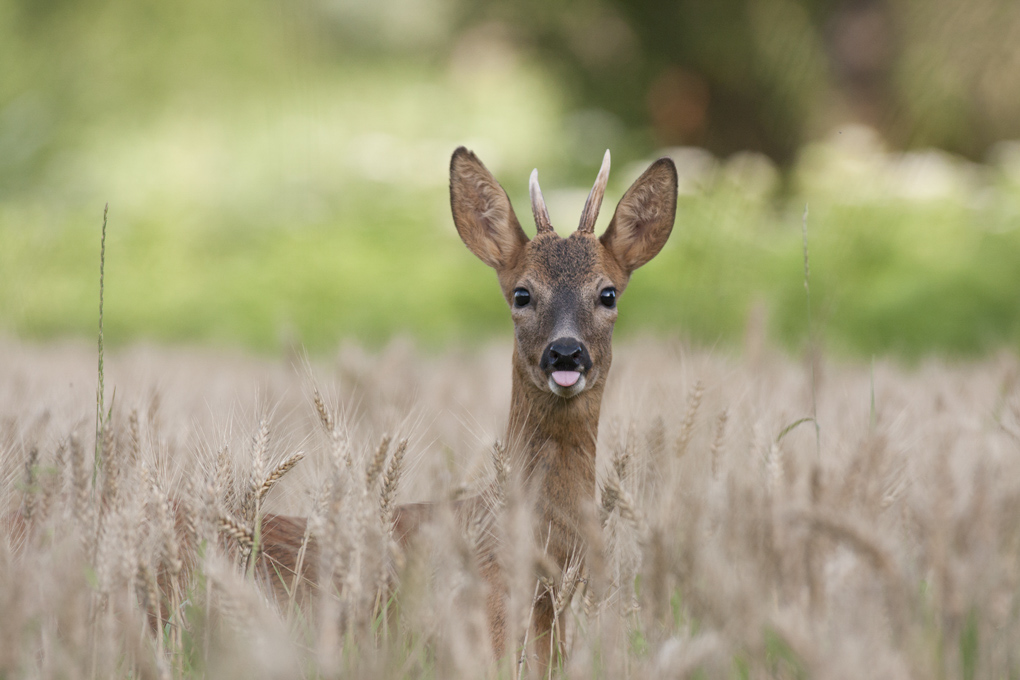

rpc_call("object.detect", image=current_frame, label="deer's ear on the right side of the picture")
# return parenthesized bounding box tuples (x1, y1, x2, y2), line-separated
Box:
(600, 158, 676, 273)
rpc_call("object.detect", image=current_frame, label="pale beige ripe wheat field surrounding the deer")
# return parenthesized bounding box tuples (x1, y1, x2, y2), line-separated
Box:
(0, 339, 1020, 679)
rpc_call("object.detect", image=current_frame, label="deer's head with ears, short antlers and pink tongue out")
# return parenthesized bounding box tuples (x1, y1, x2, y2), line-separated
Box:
(450, 147, 676, 399)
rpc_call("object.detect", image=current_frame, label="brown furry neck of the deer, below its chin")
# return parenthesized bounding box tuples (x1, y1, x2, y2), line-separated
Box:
(507, 359, 605, 567)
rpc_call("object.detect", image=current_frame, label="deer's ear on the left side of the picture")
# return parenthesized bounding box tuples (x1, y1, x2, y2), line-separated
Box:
(450, 147, 527, 271)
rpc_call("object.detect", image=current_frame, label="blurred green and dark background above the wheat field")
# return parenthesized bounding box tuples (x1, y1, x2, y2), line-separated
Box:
(0, 0, 1020, 357)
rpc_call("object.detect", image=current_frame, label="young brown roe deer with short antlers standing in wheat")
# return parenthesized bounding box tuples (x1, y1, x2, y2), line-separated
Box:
(262, 147, 676, 667)
